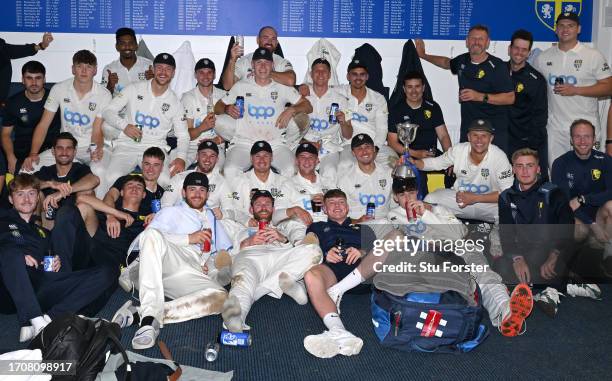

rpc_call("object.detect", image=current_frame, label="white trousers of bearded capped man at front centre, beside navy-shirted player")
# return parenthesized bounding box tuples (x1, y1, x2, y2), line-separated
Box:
(229, 245, 322, 323)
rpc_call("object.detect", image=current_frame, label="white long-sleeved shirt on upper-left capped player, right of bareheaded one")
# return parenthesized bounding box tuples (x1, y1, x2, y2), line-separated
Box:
(102, 80, 189, 159)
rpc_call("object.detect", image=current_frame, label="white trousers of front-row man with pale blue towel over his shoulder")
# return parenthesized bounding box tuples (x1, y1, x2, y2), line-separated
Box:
(134, 228, 227, 325)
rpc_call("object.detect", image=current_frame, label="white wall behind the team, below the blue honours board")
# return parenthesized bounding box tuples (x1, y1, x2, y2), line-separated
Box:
(0, 6, 612, 141)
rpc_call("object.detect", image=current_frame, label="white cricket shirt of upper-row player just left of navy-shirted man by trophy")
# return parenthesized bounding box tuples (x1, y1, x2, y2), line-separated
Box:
(339, 85, 389, 148)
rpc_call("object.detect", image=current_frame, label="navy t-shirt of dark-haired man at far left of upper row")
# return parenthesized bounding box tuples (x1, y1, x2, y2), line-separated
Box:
(2, 90, 60, 160)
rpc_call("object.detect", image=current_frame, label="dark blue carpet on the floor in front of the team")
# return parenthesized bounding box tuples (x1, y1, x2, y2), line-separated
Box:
(0, 285, 612, 381)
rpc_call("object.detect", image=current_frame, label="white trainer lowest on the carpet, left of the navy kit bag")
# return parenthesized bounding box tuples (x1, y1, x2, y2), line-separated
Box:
(304, 328, 363, 358)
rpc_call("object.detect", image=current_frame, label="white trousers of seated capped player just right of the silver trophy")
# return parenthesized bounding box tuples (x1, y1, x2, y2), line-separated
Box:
(425, 189, 499, 223)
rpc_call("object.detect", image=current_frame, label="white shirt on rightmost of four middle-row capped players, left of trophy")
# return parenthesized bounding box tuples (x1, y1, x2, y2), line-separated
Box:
(338, 163, 393, 218)
